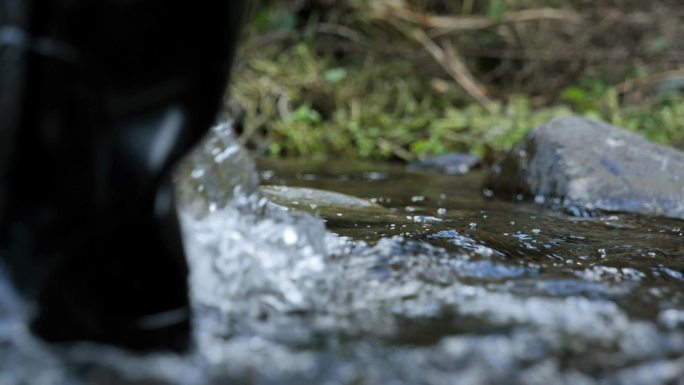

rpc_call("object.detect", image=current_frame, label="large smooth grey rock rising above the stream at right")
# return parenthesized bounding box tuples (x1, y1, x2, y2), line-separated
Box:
(487, 117, 684, 219)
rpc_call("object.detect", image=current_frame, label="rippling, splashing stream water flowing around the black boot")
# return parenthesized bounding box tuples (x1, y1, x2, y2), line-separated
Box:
(0, 125, 684, 385)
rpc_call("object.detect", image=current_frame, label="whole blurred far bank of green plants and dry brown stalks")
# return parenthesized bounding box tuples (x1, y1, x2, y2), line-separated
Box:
(226, 0, 684, 161)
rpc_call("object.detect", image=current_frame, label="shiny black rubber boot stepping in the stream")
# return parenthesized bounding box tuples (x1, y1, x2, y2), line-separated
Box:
(0, 0, 244, 350)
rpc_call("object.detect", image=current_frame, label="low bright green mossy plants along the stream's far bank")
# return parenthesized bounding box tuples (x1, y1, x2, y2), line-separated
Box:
(231, 1, 684, 161)
